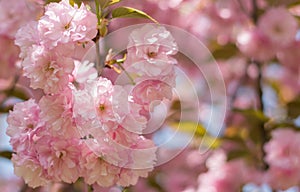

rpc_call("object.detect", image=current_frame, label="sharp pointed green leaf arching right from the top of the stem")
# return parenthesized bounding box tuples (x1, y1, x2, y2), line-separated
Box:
(112, 7, 158, 23)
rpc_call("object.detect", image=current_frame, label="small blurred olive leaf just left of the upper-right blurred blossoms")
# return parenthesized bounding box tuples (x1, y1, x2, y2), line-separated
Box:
(212, 44, 238, 59)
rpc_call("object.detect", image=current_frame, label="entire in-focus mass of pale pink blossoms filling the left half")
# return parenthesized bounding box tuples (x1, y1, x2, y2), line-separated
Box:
(7, 0, 177, 187)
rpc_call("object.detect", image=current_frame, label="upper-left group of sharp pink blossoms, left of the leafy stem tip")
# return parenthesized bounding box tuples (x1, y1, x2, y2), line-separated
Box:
(15, 0, 97, 94)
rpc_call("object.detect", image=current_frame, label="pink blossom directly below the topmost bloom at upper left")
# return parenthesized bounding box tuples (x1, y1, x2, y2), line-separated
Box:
(22, 46, 74, 93)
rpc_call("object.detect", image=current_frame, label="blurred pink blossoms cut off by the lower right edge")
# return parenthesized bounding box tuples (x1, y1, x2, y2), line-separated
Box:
(264, 129, 300, 190)
